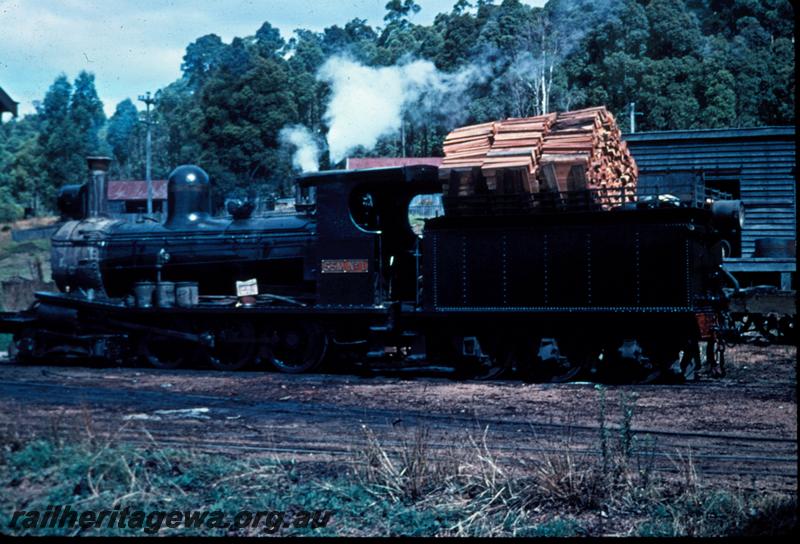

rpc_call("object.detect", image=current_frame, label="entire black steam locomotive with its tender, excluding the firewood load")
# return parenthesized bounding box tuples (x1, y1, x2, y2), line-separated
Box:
(0, 158, 743, 382)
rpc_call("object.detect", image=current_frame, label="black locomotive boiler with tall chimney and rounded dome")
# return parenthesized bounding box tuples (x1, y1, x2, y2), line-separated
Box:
(52, 159, 315, 298)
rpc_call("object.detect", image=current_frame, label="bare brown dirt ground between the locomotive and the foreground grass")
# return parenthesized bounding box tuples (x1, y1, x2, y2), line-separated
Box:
(0, 345, 797, 493)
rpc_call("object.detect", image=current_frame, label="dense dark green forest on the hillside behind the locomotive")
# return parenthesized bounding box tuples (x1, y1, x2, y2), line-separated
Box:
(0, 0, 795, 217)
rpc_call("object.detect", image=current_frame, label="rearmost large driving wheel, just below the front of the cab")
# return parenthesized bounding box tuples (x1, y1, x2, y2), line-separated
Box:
(267, 323, 328, 374)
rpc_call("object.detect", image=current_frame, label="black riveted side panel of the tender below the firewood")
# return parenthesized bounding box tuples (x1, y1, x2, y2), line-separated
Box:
(425, 220, 704, 312)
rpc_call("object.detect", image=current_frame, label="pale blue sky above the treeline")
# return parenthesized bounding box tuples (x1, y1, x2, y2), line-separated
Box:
(0, 0, 544, 115)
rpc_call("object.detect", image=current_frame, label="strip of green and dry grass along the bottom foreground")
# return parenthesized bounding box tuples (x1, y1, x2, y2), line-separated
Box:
(0, 390, 796, 536)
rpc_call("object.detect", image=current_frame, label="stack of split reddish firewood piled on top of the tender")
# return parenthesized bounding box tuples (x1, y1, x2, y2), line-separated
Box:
(439, 106, 638, 203)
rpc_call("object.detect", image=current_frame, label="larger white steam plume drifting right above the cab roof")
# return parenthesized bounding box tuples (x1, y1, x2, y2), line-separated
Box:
(317, 56, 481, 164)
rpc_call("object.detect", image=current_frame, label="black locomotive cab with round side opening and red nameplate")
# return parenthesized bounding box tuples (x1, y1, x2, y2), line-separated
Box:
(298, 166, 441, 306)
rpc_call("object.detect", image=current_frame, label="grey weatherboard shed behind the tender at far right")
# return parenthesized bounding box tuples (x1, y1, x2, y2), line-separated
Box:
(624, 126, 797, 284)
